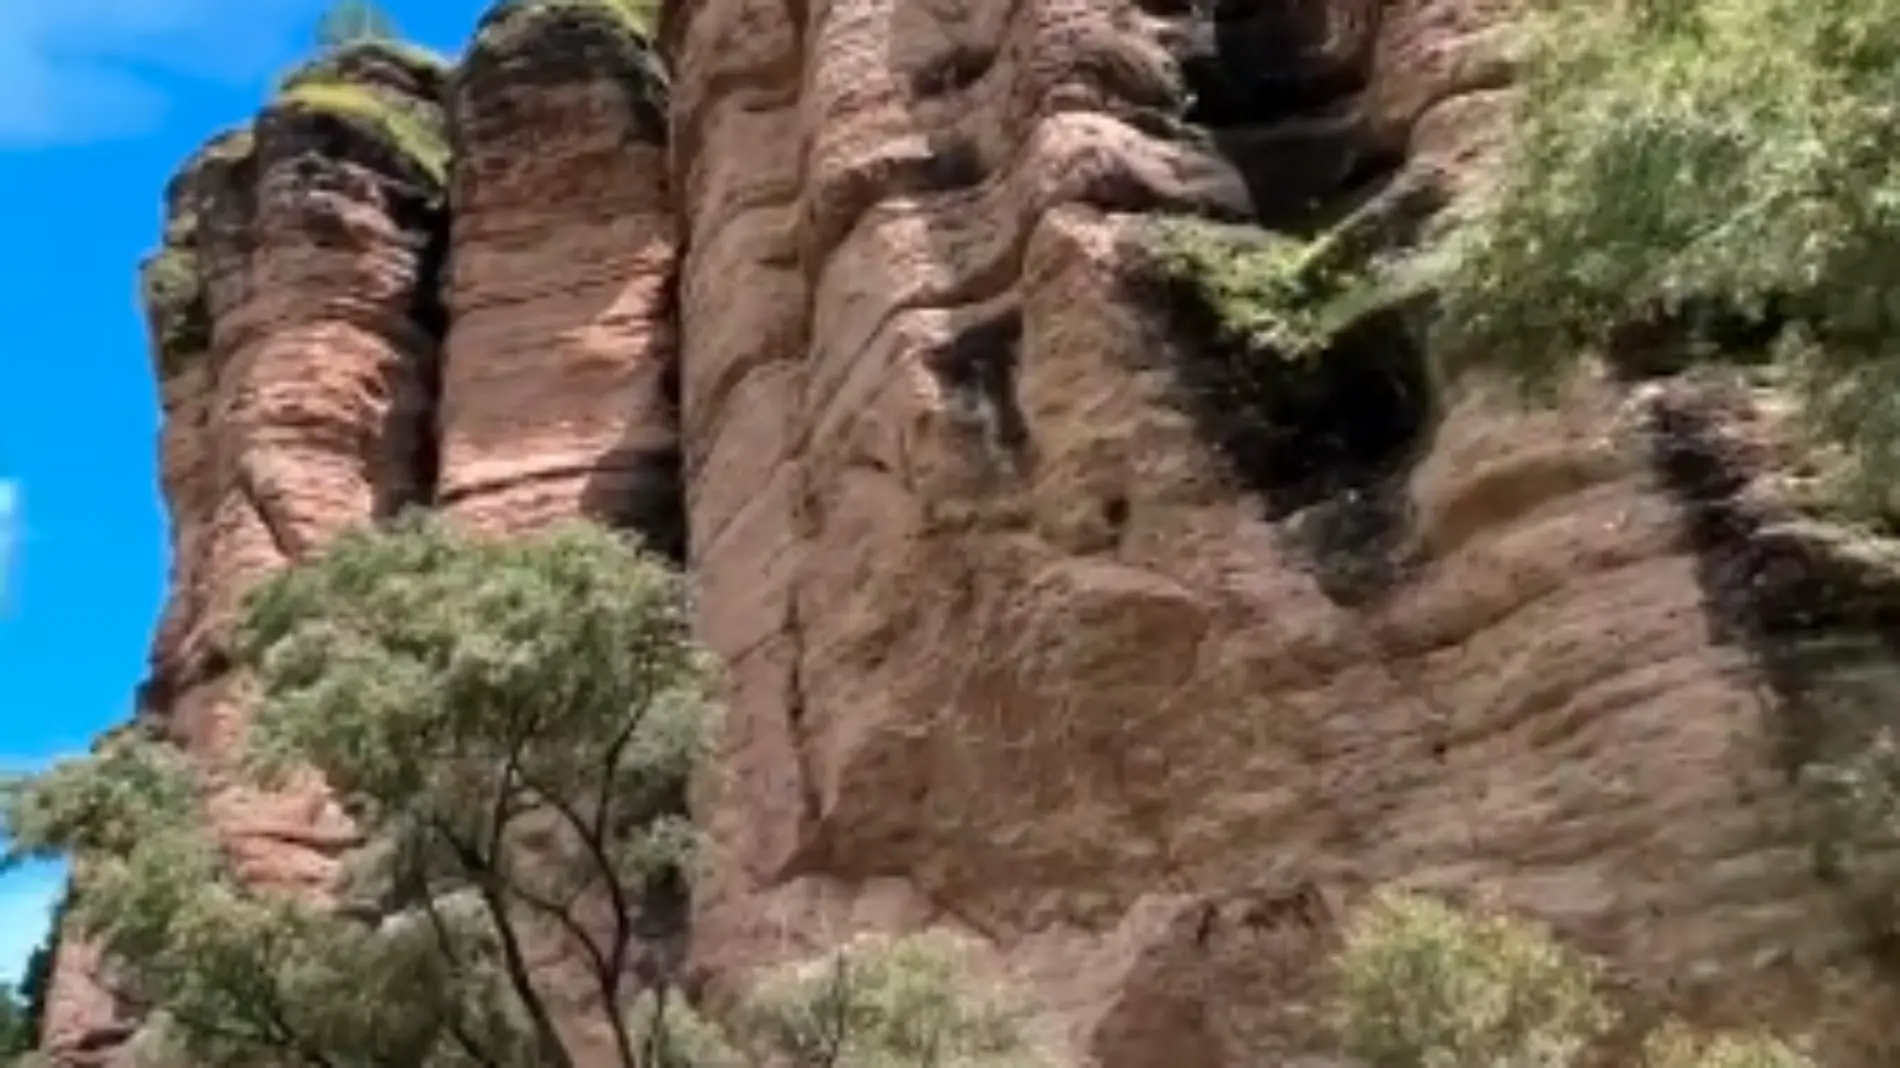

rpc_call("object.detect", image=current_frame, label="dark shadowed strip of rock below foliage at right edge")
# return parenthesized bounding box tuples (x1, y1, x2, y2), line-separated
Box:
(1649, 382, 1900, 975)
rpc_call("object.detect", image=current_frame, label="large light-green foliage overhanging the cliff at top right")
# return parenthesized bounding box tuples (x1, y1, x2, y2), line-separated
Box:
(1436, 0, 1900, 509)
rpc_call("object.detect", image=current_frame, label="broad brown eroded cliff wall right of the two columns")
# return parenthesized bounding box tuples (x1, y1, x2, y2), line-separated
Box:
(667, 0, 1889, 1068)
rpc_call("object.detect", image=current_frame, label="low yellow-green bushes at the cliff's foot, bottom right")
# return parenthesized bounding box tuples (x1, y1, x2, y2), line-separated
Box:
(1334, 889, 1816, 1068)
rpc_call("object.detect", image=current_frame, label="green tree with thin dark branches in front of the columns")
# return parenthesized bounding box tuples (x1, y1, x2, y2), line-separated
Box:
(6, 521, 713, 1068)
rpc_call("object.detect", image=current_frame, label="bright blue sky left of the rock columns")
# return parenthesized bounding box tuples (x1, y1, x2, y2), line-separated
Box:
(0, 0, 485, 979)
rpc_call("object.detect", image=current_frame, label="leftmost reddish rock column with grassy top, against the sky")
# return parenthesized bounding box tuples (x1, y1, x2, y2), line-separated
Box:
(44, 48, 447, 1066)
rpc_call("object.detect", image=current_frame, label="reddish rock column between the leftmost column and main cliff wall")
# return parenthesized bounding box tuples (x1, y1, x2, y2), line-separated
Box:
(441, 2, 684, 555)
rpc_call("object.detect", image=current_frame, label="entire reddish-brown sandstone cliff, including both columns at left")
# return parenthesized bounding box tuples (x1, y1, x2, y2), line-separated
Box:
(48, 0, 1900, 1068)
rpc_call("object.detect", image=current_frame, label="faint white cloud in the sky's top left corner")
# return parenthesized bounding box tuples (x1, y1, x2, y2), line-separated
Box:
(0, 0, 323, 148)
